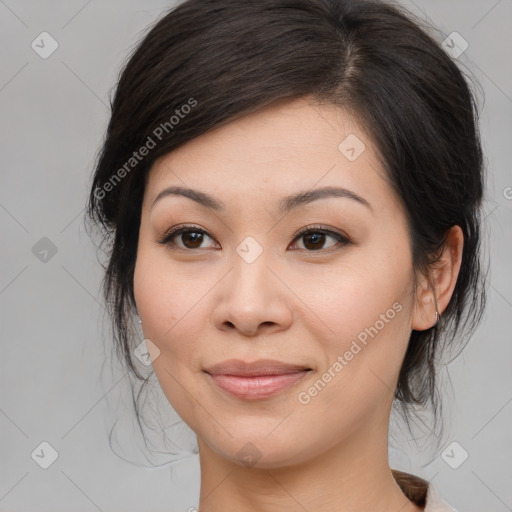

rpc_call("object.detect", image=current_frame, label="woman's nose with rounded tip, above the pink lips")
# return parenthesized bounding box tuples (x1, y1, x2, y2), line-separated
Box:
(214, 247, 293, 337)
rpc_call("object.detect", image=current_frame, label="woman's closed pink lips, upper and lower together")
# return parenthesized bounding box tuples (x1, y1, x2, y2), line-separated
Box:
(204, 359, 312, 400)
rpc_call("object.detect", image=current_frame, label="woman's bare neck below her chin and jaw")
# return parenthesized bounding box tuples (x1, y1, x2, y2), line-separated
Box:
(194, 416, 423, 512)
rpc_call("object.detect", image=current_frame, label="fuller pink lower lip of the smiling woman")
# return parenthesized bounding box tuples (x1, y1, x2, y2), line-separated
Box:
(209, 370, 310, 400)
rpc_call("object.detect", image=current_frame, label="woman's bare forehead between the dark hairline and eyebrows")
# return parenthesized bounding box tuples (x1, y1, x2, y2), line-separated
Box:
(145, 98, 393, 211)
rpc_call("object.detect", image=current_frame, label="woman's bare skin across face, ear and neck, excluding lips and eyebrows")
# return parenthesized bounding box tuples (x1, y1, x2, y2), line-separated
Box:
(134, 98, 463, 512)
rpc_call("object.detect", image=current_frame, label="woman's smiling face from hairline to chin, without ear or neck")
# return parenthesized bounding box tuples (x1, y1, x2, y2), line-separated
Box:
(134, 98, 424, 467)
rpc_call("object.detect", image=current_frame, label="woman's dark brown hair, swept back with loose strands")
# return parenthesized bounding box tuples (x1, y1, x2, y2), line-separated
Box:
(87, 0, 486, 454)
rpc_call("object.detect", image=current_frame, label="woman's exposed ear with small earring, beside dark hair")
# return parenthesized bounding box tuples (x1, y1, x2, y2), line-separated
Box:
(411, 226, 464, 331)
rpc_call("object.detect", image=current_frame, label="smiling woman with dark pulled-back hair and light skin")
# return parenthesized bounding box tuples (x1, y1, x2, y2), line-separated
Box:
(89, 0, 485, 512)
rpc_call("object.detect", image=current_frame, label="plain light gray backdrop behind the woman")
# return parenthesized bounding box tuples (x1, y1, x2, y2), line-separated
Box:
(0, 0, 512, 512)
